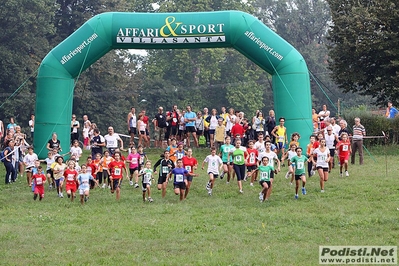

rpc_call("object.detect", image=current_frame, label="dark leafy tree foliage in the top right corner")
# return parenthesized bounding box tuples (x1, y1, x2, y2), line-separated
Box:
(327, 0, 399, 105)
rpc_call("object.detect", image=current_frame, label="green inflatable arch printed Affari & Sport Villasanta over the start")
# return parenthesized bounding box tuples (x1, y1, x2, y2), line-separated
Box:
(34, 11, 312, 158)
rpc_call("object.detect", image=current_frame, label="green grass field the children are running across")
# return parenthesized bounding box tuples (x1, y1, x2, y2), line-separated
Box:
(0, 147, 399, 265)
